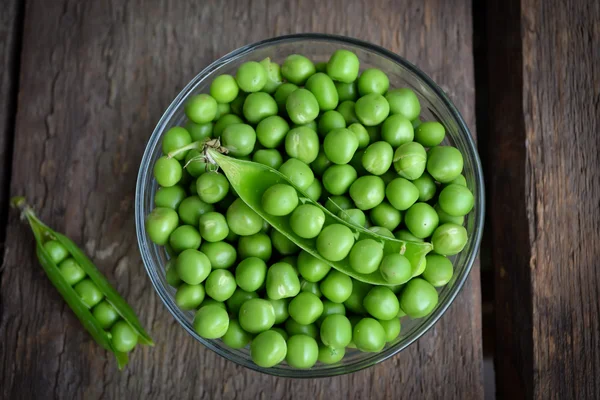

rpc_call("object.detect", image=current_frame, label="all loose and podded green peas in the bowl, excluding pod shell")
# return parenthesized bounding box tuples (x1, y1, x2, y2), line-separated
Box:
(146, 50, 474, 368)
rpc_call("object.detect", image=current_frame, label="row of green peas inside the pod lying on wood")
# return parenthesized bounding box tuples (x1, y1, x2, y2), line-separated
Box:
(44, 240, 138, 353)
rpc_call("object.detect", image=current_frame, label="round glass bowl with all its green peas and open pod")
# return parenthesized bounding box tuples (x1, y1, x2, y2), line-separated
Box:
(136, 35, 484, 377)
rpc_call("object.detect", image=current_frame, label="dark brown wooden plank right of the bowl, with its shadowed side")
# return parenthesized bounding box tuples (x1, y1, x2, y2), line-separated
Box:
(488, 0, 600, 399)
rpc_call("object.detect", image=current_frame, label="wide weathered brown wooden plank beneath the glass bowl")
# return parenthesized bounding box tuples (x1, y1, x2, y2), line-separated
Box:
(0, 0, 483, 399)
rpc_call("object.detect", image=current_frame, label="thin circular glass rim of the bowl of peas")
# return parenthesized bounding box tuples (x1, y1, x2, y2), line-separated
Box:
(135, 33, 485, 378)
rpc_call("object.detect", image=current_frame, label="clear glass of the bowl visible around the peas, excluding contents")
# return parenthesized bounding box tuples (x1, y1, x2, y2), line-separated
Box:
(135, 34, 484, 378)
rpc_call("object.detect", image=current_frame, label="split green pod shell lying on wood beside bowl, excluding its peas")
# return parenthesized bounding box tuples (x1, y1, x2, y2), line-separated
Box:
(11, 197, 154, 369)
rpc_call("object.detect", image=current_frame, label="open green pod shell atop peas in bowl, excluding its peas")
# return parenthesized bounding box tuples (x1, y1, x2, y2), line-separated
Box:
(205, 148, 433, 285)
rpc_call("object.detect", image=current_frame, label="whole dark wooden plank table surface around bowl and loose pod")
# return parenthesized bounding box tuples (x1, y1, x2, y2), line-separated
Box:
(0, 0, 600, 399)
